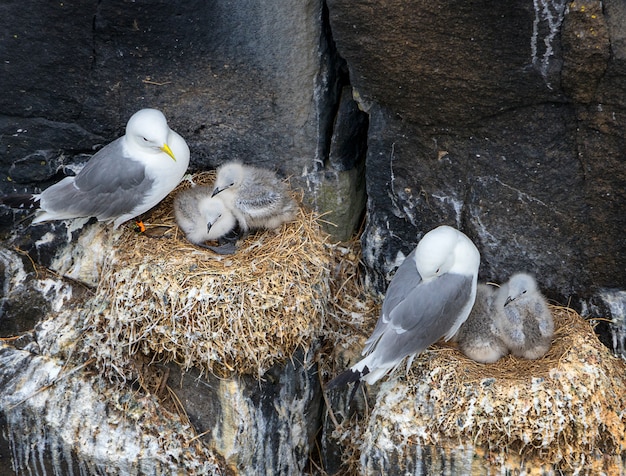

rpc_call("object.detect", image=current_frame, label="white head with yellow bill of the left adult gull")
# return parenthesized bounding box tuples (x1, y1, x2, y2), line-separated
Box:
(126, 109, 176, 160)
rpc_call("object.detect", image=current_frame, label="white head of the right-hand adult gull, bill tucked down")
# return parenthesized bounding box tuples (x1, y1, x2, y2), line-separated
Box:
(415, 225, 480, 281)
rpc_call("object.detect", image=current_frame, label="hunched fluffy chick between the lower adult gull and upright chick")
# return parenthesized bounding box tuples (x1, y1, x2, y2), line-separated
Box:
(454, 284, 509, 364)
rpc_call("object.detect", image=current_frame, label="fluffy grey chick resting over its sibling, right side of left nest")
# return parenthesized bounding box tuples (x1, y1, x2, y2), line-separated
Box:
(213, 161, 298, 232)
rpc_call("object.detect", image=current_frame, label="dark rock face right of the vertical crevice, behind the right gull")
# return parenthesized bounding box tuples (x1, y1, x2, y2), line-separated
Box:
(329, 0, 626, 302)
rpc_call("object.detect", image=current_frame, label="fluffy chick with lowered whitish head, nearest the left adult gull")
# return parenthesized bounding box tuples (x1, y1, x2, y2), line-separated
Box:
(174, 185, 237, 249)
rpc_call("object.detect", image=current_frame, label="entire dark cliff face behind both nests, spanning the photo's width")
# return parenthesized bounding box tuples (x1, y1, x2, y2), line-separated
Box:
(0, 0, 626, 300)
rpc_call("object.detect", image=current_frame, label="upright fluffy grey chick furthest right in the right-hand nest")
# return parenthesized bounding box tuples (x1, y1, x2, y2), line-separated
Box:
(494, 273, 554, 360)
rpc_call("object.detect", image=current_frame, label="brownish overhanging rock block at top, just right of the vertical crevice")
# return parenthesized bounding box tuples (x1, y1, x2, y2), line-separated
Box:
(328, 0, 565, 126)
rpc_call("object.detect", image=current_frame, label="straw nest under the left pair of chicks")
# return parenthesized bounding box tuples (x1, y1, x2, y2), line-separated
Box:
(91, 172, 330, 378)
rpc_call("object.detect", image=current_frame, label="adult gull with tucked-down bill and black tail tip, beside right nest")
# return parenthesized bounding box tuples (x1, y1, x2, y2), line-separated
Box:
(327, 226, 480, 388)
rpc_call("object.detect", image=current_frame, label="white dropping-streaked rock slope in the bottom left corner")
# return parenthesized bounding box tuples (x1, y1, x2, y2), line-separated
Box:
(0, 342, 228, 476)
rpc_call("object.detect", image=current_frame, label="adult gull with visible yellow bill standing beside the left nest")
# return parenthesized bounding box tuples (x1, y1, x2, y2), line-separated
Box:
(2, 109, 189, 228)
